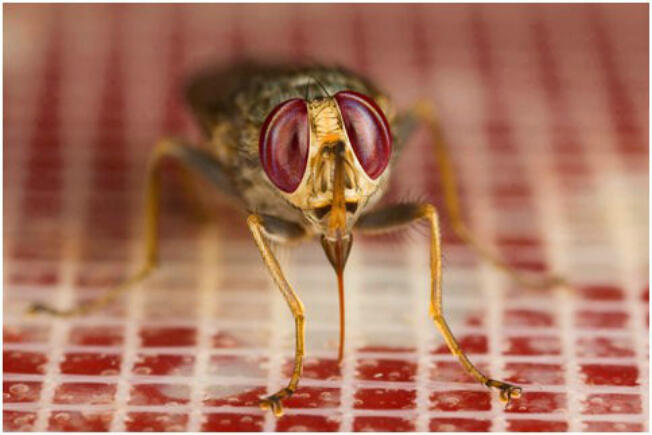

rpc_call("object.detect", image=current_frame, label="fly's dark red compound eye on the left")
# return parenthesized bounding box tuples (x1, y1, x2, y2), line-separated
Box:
(258, 98, 310, 193)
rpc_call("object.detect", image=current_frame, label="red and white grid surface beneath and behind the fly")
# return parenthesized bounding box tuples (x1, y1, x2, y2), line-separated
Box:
(3, 5, 649, 431)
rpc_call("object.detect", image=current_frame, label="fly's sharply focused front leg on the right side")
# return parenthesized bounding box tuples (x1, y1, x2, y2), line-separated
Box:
(356, 203, 521, 406)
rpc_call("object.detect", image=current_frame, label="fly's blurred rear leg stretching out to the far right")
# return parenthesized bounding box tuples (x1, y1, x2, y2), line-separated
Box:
(398, 102, 569, 289)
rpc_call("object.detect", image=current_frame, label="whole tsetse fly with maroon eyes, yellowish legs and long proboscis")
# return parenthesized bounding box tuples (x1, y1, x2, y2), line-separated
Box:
(31, 64, 562, 416)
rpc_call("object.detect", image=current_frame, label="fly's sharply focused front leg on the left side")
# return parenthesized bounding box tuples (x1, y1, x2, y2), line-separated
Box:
(247, 214, 305, 417)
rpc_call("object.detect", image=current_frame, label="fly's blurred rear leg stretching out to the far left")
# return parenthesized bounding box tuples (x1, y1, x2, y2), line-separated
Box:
(28, 139, 234, 317)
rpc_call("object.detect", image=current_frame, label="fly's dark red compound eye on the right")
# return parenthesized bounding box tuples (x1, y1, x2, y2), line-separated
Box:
(335, 91, 392, 180)
